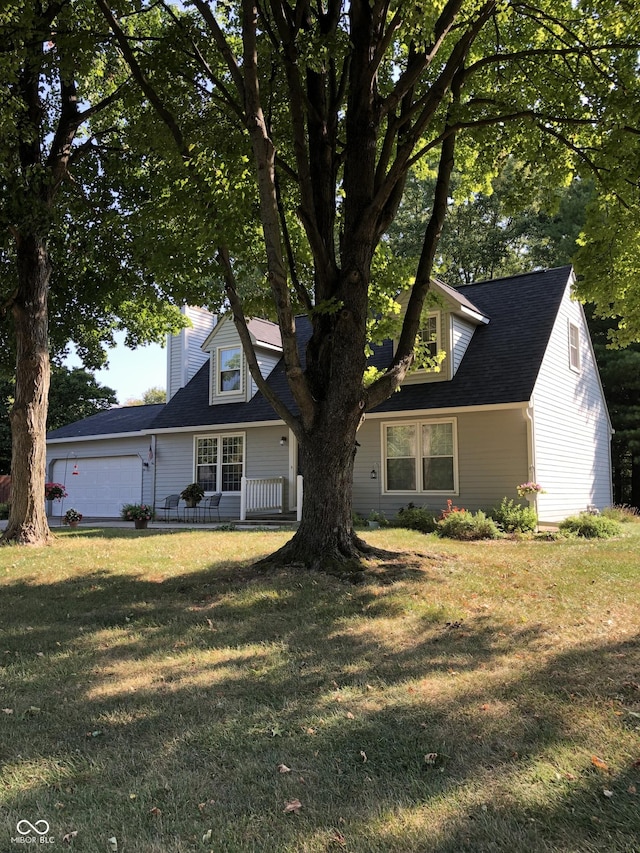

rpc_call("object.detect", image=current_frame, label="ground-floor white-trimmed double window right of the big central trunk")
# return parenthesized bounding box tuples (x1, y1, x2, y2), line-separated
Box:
(384, 420, 458, 493)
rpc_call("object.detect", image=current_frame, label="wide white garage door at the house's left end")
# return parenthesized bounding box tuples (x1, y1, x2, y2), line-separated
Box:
(51, 456, 141, 518)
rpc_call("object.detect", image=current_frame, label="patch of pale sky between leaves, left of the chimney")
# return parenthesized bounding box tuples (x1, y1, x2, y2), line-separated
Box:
(66, 332, 167, 406)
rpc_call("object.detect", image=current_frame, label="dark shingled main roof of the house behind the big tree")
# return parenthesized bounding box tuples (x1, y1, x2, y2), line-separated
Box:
(48, 266, 571, 438)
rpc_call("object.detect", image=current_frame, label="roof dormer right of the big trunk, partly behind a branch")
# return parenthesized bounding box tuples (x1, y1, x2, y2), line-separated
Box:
(398, 279, 489, 384)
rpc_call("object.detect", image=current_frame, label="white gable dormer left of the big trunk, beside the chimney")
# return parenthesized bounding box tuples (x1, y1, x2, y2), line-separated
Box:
(202, 314, 282, 406)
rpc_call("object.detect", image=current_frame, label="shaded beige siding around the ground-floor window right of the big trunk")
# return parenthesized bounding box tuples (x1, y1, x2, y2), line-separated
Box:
(353, 408, 528, 517)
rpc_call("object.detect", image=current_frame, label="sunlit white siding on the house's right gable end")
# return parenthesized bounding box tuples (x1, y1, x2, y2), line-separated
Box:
(530, 286, 612, 521)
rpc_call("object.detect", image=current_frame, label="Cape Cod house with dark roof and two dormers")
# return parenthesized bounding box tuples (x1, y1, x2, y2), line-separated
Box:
(47, 267, 612, 522)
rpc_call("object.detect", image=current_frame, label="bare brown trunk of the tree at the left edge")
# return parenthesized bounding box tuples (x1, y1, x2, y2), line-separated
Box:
(2, 235, 51, 545)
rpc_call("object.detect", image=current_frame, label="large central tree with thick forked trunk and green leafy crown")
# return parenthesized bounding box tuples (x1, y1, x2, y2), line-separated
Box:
(97, 0, 640, 563)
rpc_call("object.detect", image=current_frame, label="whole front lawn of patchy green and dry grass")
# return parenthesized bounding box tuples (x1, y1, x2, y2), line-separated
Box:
(0, 525, 640, 853)
